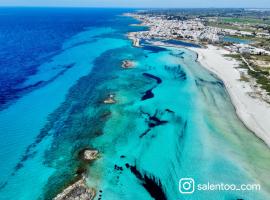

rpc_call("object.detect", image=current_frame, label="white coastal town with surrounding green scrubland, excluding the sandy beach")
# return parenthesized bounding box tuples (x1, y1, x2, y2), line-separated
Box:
(126, 9, 270, 103)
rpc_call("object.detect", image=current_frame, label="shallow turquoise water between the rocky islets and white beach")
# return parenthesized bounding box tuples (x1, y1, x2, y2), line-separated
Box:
(83, 46, 269, 199)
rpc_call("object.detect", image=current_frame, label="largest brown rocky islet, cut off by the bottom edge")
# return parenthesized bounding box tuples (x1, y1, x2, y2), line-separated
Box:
(53, 177, 96, 200)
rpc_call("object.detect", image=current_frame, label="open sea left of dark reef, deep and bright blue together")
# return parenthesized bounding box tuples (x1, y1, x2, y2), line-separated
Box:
(0, 8, 140, 199)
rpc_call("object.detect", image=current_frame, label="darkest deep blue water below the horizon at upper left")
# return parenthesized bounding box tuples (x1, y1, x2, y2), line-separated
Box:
(0, 8, 139, 110)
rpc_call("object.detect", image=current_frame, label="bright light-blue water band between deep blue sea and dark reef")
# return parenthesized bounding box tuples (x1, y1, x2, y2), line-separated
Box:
(0, 24, 131, 199)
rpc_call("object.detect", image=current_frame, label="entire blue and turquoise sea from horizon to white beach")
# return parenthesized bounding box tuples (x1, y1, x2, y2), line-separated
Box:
(0, 8, 270, 200)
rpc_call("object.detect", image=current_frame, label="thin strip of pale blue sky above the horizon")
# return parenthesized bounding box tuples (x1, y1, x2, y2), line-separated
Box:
(0, 0, 270, 8)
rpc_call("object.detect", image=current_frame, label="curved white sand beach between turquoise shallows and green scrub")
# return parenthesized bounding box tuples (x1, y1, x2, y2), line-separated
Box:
(189, 45, 270, 147)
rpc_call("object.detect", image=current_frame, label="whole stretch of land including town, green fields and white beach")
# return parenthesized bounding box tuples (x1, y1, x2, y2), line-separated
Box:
(125, 9, 270, 146)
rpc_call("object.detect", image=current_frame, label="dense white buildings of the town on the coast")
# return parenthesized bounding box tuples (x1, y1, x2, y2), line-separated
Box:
(127, 14, 270, 55)
